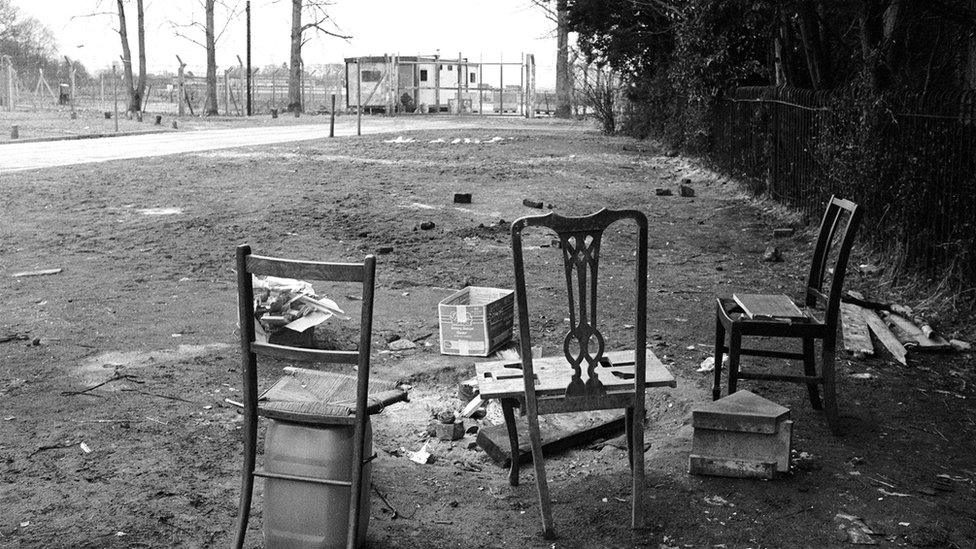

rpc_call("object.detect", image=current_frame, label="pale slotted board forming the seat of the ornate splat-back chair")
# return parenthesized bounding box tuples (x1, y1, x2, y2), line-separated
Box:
(475, 349, 676, 400)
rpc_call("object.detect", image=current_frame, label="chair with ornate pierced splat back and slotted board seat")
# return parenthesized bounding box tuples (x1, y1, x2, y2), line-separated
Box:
(479, 209, 675, 538)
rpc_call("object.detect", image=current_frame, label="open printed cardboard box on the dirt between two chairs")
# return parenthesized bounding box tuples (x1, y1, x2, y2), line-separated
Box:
(437, 286, 515, 356)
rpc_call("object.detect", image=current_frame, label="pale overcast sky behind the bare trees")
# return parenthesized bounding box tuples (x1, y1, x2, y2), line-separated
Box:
(12, 0, 556, 88)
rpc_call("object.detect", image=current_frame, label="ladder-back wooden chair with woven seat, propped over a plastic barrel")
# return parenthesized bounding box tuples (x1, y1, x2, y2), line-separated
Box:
(234, 246, 407, 549)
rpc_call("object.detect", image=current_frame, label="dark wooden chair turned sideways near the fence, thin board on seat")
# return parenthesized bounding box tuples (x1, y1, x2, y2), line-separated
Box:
(712, 197, 861, 433)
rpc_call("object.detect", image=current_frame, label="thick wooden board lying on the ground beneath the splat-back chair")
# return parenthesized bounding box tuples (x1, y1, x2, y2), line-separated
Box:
(477, 410, 624, 467)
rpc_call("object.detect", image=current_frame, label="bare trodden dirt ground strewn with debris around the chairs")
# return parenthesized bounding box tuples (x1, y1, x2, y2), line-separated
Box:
(0, 117, 976, 548)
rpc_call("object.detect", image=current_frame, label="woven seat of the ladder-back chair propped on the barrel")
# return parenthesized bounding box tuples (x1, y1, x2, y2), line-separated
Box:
(258, 368, 407, 425)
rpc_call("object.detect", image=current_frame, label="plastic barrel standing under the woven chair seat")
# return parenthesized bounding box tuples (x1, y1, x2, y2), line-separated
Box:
(263, 421, 373, 549)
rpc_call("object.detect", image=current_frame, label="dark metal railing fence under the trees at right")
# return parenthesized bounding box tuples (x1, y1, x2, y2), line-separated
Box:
(712, 83, 976, 285)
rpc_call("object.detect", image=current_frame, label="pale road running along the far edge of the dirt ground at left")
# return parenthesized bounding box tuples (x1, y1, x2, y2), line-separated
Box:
(0, 117, 477, 173)
